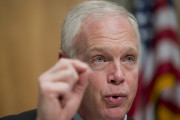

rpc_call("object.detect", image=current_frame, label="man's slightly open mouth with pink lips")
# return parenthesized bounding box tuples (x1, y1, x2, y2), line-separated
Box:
(104, 93, 126, 106)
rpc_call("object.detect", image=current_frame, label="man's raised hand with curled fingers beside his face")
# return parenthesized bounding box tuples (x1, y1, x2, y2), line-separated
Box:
(37, 58, 91, 120)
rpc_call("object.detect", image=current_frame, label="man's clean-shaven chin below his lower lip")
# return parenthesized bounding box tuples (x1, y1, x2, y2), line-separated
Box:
(105, 108, 126, 120)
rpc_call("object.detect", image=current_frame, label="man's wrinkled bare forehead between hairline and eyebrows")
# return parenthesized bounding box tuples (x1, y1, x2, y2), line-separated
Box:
(76, 15, 137, 57)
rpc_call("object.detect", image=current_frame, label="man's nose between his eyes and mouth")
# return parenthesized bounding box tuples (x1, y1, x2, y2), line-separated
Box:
(108, 64, 125, 85)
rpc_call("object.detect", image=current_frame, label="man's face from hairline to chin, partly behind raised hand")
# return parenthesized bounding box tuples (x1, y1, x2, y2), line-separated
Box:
(77, 16, 138, 120)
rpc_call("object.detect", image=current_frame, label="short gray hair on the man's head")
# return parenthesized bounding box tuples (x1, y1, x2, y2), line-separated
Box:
(61, 1, 141, 57)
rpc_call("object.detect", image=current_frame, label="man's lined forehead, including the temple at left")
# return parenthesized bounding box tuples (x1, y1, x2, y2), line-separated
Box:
(73, 15, 136, 57)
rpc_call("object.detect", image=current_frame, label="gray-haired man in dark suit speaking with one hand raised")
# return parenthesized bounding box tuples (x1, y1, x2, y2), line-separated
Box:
(0, 1, 140, 120)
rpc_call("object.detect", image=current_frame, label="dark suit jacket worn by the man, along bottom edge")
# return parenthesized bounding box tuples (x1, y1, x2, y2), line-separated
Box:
(0, 110, 133, 120)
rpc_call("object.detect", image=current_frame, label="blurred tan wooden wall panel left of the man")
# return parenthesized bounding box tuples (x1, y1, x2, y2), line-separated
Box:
(0, 0, 86, 117)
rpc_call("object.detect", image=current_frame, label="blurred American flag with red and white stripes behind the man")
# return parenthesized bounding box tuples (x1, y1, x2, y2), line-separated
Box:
(129, 0, 180, 120)
